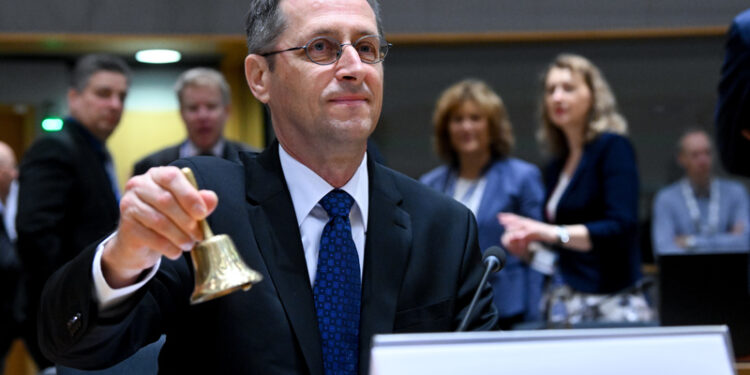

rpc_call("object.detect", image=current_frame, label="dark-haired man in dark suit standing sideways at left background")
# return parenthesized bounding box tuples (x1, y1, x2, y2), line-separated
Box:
(16, 55, 130, 368)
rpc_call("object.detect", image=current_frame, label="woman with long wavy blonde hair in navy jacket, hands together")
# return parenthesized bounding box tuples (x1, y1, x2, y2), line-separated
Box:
(499, 54, 651, 324)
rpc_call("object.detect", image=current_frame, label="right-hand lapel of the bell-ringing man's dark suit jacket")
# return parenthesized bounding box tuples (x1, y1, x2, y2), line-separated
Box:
(359, 157, 412, 374)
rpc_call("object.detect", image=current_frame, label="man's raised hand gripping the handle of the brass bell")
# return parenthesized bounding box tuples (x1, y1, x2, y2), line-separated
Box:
(102, 167, 218, 288)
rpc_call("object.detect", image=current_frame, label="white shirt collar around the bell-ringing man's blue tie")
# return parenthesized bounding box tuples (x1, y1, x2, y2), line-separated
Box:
(279, 144, 369, 228)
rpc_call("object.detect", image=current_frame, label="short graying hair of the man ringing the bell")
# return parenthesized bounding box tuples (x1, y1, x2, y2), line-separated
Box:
(245, 0, 384, 67)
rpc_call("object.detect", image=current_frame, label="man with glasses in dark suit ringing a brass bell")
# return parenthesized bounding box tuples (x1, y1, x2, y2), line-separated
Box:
(39, 0, 497, 374)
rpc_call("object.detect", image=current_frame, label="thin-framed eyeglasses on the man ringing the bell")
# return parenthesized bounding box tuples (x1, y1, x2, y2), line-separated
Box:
(260, 35, 392, 65)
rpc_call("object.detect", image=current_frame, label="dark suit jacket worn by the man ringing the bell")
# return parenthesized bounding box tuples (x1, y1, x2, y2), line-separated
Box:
(39, 143, 497, 375)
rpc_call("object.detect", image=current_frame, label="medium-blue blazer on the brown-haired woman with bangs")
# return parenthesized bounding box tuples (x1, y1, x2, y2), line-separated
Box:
(420, 158, 544, 321)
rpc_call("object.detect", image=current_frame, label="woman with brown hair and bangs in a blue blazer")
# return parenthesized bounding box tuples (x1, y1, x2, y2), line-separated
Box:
(421, 80, 544, 329)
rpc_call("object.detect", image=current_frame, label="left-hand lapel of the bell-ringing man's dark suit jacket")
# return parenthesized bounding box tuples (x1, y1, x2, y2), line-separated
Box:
(240, 142, 323, 374)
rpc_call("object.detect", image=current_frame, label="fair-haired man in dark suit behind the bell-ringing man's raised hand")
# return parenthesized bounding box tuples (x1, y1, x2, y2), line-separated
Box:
(133, 68, 258, 176)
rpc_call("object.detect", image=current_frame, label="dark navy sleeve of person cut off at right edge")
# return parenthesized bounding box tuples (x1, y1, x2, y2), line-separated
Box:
(716, 9, 750, 176)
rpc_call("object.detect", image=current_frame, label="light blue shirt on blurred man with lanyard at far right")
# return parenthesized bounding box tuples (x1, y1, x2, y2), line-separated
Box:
(651, 179, 750, 255)
